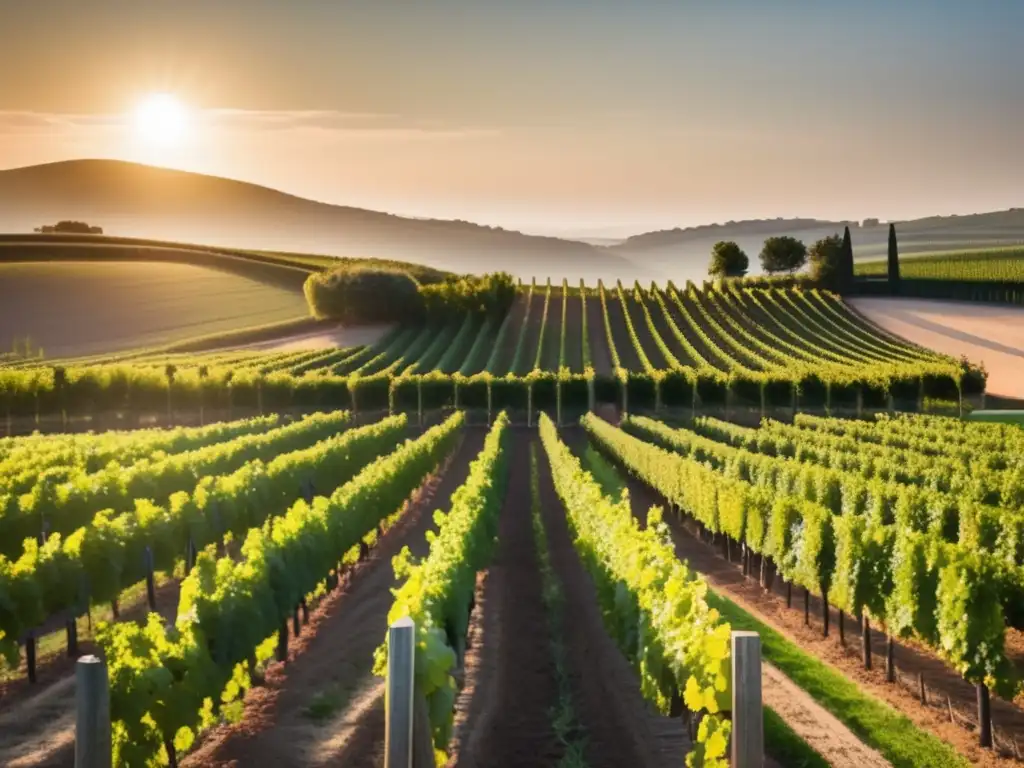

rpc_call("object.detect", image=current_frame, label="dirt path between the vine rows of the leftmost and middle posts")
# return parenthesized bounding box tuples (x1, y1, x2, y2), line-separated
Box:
(181, 430, 484, 768)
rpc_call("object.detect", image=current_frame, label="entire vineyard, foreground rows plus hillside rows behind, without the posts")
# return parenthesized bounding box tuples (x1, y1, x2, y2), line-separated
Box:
(0, 265, 1024, 768)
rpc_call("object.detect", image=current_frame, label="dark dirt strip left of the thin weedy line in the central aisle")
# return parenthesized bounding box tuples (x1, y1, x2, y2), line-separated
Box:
(449, 430, 561, 768)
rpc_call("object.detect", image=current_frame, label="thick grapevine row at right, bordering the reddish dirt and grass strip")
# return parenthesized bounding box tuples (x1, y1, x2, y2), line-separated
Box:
(585, 416, 1024, 697)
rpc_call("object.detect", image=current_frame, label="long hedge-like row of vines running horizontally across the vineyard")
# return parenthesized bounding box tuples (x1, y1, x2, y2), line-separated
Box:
(0, 365, 984, 419)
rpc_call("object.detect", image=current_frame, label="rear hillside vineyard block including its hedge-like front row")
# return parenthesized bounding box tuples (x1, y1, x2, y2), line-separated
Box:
(0, 282, 984, 436)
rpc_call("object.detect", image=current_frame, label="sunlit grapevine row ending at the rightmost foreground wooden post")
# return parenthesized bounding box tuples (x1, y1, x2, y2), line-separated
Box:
(540, 415, 731, 767)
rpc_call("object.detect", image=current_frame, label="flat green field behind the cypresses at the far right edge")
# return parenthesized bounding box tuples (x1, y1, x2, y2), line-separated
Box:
(856, 246, 1024, 283)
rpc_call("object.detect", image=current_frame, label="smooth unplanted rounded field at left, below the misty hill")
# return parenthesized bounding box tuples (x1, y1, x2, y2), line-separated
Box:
(0, 261, 307, 357)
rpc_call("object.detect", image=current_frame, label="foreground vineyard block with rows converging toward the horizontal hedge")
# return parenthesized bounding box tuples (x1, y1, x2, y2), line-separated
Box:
(6, 391, 1024, 766)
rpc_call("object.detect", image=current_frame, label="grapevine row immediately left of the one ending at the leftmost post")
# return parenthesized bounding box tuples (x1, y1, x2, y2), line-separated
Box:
(0, 416, 407, 660)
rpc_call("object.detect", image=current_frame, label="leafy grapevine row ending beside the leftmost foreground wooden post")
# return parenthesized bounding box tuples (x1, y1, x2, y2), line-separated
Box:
(98, 414, 463, 765)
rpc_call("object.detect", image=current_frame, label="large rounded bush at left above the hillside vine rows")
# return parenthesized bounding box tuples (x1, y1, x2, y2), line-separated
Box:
(303, 266, 423, 324)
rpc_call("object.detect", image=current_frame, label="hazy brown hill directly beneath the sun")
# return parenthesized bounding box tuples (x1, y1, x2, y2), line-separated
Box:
(0, 160, 642, 280)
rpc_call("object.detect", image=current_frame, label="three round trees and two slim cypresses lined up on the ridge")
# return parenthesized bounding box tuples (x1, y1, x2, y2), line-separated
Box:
(708, 224, 899, 293)
